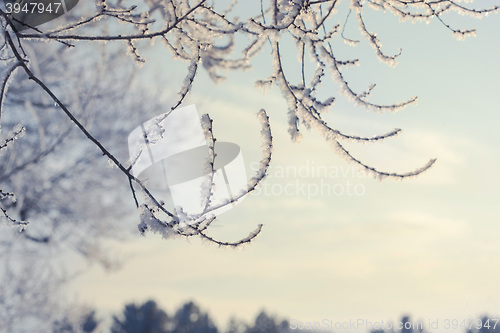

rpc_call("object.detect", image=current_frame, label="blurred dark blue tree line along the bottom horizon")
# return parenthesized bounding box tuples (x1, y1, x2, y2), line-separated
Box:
(53, 300, 500, 333)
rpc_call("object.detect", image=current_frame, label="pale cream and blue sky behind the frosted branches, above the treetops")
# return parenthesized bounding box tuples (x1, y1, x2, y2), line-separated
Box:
(70, 1, 500, 325)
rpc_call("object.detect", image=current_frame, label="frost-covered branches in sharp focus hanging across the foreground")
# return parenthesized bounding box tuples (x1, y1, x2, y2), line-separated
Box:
(0, 0, 500, 245)
